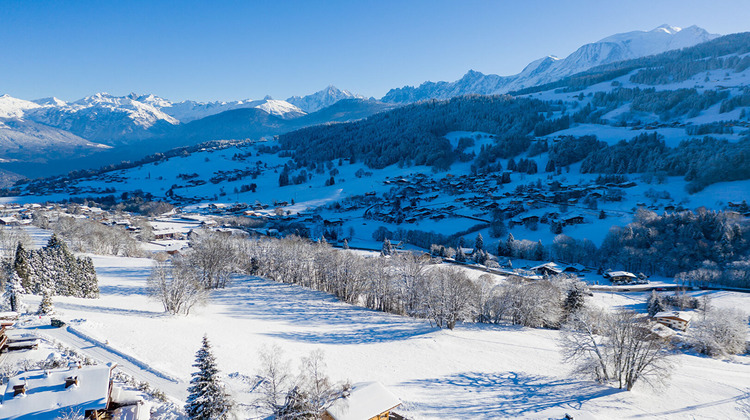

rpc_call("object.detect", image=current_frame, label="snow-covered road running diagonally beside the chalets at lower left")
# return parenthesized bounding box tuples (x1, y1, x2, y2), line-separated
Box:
(34, 326, 188, 402)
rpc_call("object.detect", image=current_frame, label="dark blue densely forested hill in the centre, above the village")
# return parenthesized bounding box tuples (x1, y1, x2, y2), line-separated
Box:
(279, 96, 550, 169)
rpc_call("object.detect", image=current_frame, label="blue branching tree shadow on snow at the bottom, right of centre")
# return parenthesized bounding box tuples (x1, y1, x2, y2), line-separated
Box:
(402, 372, 624, 419)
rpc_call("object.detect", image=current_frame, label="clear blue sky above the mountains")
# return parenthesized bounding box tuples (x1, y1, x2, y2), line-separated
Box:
(0, 0, 750, 101)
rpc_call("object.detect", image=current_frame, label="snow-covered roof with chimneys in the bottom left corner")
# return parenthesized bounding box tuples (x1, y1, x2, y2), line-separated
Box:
(0, 365, 111, 420)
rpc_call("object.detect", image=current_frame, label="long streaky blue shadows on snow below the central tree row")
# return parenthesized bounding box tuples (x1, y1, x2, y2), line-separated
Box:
(211, 277, 437, 344)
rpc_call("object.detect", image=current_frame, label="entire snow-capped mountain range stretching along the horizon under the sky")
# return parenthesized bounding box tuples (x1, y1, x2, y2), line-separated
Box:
(0, 25, 732, 176)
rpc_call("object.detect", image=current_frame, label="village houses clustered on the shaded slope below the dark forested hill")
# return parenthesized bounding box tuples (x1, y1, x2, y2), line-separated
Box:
(337, 173, 637, 228)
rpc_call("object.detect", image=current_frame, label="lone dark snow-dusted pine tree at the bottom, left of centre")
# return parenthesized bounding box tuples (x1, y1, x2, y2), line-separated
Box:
(185, 335, 233, 420)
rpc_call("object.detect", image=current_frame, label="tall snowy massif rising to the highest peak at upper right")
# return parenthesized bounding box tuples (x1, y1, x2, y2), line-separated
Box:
(382, 25, 719, 103)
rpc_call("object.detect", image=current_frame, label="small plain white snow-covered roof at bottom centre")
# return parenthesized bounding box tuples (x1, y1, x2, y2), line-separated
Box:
(326, 382, 401, 420)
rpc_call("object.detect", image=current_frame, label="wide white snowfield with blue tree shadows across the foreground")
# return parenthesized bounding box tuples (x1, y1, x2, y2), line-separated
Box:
(16, 256, 750, 419)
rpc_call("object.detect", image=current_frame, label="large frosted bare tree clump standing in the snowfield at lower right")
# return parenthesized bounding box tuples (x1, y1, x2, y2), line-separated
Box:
(561, 310, 671, 391)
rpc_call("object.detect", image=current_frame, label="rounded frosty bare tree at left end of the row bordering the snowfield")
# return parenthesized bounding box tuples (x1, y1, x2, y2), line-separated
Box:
(148, 258, 207, 315)
